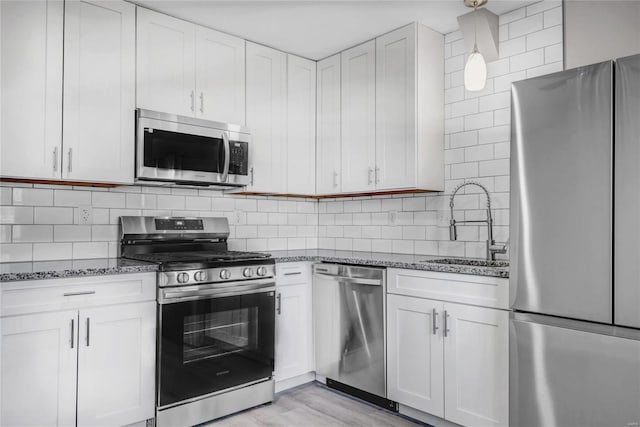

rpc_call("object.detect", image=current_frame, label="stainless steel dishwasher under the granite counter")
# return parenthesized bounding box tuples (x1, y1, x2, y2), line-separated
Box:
(313, 263, 398, 411)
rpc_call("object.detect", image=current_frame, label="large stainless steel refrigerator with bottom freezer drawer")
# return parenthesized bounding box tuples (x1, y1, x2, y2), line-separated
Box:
(510, 55, 640, 427)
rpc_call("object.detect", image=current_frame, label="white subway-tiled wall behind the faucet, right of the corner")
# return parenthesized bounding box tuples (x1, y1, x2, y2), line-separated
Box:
(318, 0, 563, 257)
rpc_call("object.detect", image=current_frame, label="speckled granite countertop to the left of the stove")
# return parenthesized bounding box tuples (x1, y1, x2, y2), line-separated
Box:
(0, 258, 158, 282)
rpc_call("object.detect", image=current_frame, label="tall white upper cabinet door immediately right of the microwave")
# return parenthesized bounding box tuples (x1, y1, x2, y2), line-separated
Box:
(247, 42, 287, 193)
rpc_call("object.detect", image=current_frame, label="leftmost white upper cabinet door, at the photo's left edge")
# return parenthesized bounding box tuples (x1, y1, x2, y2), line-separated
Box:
(0, 0, 64, 179)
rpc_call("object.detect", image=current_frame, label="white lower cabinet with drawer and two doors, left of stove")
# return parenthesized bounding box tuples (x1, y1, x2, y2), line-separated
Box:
(0, 273, 156, 427)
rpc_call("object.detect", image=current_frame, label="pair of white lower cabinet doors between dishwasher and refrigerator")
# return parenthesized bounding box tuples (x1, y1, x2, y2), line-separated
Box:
(387, 294, 509, 426)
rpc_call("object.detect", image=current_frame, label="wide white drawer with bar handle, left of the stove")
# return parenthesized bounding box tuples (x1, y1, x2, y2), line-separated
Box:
(0, 273, 156, 316)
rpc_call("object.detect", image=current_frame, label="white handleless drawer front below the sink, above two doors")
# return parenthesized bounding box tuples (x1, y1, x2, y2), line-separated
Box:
(387, 268, 509, 309)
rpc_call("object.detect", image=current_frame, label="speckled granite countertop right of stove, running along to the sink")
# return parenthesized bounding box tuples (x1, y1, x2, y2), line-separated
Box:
(268, 249, 509, 278)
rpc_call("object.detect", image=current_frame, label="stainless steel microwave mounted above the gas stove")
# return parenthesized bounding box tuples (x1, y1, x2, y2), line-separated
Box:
(136, 109, 251, 188)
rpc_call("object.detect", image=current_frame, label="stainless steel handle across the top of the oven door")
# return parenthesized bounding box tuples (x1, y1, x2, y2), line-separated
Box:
(159, 279, 275, 304)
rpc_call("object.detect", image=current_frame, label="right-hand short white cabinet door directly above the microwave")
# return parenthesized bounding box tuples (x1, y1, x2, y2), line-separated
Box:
(195, 26, 245, 126)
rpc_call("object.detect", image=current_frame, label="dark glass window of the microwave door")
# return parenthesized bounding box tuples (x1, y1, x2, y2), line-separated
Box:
(144, 129, 224, 173)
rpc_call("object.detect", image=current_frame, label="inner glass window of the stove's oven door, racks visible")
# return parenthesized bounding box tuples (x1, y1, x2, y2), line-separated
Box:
(182, 307, 258, 363)
